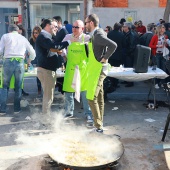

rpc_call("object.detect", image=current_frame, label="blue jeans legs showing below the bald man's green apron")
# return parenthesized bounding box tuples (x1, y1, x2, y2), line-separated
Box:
(65, 91, 92, 116)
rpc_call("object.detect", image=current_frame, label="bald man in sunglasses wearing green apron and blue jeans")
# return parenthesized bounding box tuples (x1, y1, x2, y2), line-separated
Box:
(63, 20, 93, 123)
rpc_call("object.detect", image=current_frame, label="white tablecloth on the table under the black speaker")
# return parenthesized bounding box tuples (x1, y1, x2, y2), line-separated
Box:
(108, 67, 168, 82)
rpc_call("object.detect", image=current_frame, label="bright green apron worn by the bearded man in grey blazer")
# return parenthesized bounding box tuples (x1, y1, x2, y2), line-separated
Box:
(86, 42, 102, 100)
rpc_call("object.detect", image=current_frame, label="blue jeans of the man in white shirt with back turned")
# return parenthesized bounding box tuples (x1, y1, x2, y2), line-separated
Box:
(0, 59, 25, 112)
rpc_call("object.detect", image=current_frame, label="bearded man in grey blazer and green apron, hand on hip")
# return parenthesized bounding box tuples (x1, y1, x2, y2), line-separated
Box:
(85, 14, 117, 133)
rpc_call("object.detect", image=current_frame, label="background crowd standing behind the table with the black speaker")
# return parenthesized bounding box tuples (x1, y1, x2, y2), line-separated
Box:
(105, 18, 170, 92)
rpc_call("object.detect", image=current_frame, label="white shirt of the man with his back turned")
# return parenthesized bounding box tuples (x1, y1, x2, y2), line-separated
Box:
(0, 31, 35, 60)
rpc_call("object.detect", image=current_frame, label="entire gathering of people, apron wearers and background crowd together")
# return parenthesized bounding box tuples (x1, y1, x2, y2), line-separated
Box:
(0, 14, 170, 133)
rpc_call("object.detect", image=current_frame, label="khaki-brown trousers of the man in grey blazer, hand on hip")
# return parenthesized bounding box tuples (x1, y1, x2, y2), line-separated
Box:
(88, 73, 106, 129)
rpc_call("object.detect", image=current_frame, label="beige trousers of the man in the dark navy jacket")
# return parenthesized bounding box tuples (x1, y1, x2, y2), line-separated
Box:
(37, 67, 57, 116)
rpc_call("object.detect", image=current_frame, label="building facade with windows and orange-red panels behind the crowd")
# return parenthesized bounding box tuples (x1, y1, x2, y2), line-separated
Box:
(0, 0, 167, 37)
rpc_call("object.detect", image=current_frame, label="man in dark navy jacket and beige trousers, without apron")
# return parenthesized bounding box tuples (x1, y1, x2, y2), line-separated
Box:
(35, 19, 70, 124)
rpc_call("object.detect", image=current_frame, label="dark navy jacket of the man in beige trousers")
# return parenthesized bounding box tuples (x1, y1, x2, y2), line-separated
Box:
(35, 32, 69, 71)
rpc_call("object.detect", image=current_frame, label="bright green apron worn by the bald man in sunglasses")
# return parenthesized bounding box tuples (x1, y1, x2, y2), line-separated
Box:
(63, 37, 88, 92)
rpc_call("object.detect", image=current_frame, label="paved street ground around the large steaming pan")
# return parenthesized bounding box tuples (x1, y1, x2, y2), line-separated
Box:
(0, 79, 170, 170)
